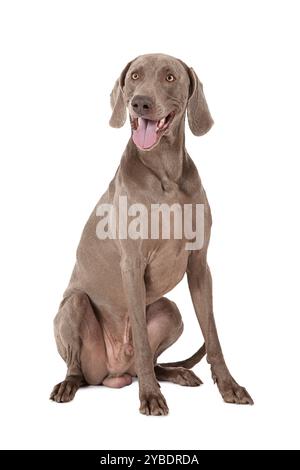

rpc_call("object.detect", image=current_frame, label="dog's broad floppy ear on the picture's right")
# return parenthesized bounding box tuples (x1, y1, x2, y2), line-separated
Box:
(187, 68, 214, 135)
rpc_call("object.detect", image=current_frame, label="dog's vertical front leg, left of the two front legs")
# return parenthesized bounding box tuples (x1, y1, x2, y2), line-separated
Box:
(121, 256, 169, 416)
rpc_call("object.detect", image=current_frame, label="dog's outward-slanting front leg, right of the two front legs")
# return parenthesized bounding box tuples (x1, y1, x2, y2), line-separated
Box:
(187, 251, 253, 405)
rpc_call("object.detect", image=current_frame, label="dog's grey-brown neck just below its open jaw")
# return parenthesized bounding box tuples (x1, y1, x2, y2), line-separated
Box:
(128, 119, 186, 187)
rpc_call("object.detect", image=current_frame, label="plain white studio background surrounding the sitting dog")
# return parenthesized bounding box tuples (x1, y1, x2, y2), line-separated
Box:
(0, 0, 300, 449)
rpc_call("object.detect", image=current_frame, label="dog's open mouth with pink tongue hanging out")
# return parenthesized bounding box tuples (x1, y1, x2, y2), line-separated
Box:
(130, 111, 175, 150)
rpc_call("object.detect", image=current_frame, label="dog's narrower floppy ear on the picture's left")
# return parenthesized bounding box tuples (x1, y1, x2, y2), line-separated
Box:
(109, 62, 132, 128)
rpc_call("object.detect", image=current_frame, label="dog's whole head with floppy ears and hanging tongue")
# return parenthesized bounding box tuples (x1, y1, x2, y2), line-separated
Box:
(110, 54, 213, 151)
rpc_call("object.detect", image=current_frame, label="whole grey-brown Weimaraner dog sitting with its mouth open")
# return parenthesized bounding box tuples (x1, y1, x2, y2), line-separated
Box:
(50, 54, 253, 415)
